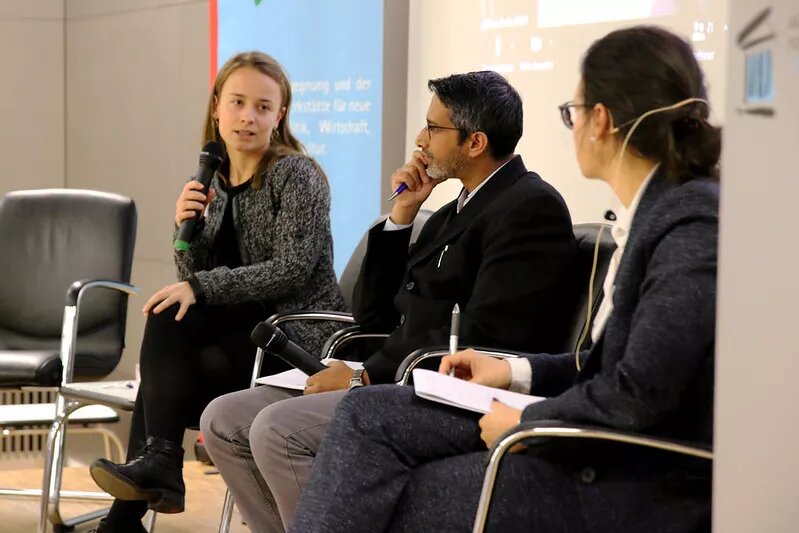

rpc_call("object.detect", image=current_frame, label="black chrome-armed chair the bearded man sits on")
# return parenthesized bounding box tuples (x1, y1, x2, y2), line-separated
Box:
(394, 223, 616, 385)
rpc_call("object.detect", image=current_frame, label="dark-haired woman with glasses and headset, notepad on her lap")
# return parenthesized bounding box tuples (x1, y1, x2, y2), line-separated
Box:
(292, 27, 721, 533)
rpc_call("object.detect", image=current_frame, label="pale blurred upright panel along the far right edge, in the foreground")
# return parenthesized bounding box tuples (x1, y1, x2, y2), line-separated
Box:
(714, 0, 799, 533)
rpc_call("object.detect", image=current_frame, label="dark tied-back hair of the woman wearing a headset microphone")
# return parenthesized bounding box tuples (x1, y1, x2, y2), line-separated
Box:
(582, 26, 721, 183)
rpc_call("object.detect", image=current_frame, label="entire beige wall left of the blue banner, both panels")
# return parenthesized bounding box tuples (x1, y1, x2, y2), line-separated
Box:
(0, 0, 209, 460)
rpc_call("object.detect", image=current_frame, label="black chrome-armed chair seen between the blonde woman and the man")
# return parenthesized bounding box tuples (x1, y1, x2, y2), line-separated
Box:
(219, 209, 433, 533)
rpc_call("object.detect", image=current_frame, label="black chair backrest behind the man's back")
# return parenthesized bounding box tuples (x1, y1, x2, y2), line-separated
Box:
(565, 223, 616, 351)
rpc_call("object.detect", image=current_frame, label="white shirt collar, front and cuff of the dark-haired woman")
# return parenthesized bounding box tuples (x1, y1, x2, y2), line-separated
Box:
(506, 165, 659, 394)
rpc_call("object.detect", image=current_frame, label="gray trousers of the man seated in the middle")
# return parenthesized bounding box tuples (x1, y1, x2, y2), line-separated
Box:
(200, 386, 346, 533)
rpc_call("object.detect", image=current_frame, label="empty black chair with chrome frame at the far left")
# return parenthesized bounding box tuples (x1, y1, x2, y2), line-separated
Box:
(0, 189, 136, 533)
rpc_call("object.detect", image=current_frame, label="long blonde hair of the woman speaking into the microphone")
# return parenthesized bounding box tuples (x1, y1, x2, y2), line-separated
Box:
(202, 51, 306, 189)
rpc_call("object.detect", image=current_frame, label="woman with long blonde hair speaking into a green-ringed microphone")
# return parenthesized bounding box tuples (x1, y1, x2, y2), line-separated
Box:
(91, 52, 344, 532)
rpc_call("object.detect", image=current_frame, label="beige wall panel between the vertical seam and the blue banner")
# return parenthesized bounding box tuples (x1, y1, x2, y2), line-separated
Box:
(65, 0, 210, 458)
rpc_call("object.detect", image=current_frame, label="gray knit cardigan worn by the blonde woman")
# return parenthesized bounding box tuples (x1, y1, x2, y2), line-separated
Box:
(175, 155, 345, 354)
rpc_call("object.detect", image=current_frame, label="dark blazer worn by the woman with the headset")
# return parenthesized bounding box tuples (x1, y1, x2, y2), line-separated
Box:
(522, 168, 719, 532)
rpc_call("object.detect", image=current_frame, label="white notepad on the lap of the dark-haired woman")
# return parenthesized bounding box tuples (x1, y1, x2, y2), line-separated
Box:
(413, 368, 546, 413)
